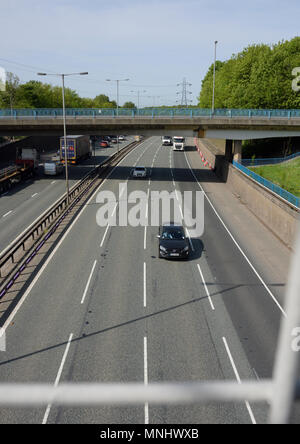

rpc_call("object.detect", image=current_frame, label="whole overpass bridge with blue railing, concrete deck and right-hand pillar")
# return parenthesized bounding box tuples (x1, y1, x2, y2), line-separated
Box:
(0, 108, 300, 161)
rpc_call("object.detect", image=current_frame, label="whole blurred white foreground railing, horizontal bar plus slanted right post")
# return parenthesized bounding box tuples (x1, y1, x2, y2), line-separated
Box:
(0, 225, 300, 424)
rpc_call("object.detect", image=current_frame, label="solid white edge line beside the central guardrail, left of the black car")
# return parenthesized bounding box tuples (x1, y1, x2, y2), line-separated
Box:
(2, 139, 146, 332)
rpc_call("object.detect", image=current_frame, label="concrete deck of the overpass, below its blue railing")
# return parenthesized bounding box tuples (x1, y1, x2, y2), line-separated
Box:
(0, 114, 300, 140)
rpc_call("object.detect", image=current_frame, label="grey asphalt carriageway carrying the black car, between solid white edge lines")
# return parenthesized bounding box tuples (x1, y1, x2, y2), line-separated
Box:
(0, 137, 292, 424)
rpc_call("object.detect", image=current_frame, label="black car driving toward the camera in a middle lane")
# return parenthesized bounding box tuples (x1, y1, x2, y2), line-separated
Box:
(158, 223, 190, 259)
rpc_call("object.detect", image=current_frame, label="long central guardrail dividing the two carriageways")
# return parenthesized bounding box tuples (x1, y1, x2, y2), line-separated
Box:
(0, 141, 140, 300)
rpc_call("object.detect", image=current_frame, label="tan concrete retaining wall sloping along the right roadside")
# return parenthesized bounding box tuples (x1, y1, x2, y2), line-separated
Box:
(197, 139, 300, 248)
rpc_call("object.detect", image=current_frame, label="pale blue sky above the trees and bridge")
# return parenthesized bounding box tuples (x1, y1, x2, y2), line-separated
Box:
(0, 0, 300, 105)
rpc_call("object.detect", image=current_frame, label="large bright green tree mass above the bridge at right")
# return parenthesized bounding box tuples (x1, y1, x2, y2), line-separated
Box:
(198, 37, 300, 109)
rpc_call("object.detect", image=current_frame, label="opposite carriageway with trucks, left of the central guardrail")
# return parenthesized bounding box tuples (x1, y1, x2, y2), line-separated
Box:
(0, 137, 133, 253)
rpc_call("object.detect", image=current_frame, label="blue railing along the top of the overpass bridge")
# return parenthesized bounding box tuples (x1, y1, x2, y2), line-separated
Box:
(0, 108, 300, 120)
